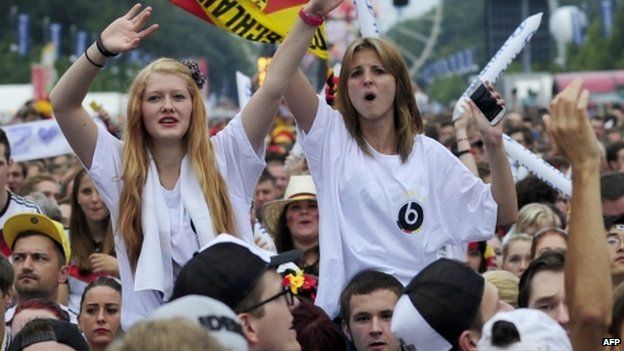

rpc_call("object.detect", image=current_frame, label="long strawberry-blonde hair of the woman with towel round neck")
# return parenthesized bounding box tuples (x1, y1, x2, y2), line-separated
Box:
(118, 58, 236, 270)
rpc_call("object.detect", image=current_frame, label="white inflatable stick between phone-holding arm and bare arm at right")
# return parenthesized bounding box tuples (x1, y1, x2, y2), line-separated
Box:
(503, 134, 572, 198)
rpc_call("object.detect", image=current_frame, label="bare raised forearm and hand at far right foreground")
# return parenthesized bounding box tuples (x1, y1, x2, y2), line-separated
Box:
(544, 79, 613, 351)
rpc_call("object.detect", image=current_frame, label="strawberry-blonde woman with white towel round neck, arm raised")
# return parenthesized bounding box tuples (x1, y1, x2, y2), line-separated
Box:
(50, 4, 279, 329)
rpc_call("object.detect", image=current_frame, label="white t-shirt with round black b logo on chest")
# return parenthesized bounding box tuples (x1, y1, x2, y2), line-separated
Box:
(297, 97, 497, 317)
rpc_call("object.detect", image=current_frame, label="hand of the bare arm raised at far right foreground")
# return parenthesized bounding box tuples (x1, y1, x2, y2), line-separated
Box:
(543, 78, 600, 168)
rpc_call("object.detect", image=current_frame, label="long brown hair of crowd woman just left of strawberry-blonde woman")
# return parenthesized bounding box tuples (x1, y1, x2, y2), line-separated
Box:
(69, 169, 115, 274)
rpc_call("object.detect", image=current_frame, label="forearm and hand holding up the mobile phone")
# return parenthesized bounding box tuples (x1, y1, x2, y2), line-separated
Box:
(468, 82, 518, 225)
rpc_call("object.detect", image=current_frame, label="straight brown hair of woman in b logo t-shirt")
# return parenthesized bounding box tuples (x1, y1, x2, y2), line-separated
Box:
(336, 38, 423, 162)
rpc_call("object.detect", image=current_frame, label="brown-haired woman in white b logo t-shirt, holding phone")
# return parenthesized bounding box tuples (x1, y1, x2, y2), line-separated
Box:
(249, 0, 517, 317)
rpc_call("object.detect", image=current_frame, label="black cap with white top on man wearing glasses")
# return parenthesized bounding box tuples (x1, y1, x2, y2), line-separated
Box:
(171, 234, 302, 309)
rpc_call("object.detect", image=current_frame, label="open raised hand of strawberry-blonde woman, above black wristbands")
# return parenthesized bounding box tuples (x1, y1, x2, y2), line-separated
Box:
(101, 4, 158, 53)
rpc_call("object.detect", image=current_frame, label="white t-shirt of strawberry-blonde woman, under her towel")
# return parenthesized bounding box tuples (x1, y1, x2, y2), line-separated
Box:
(89, 114, 265, 330)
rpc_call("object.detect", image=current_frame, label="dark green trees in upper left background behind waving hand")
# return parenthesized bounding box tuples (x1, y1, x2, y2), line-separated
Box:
(0, 0, 256, 96)
